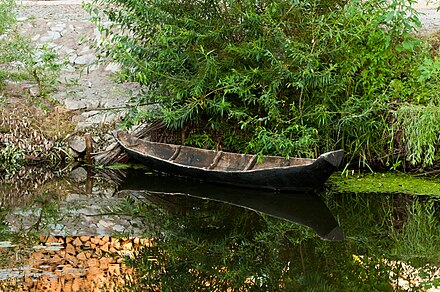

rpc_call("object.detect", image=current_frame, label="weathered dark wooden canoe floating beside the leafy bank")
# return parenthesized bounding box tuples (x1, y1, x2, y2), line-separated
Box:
(115, 131, 343, 191)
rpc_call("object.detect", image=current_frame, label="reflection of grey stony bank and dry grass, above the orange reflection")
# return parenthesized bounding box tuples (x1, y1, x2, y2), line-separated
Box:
(0, 168, 128, 241)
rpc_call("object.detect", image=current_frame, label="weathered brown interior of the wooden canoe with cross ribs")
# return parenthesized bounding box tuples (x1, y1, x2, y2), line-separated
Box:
(119, 135, 315, 171)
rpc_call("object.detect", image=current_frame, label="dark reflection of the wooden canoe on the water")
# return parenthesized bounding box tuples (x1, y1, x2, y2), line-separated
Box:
(120, 174, 344, 240)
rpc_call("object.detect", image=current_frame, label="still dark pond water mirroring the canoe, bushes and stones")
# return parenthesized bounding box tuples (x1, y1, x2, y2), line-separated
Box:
(0, 168, 440, 291)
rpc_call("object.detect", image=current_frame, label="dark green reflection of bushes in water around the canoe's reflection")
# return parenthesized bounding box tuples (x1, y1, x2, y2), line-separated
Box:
(122, 194, 440, 291)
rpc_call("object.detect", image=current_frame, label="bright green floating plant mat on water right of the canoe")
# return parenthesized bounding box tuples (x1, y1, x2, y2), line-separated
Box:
(329, 173, 440, 197)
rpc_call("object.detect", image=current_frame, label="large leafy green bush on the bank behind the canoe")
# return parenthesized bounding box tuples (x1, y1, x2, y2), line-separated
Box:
(86, 0, 436, 163)
